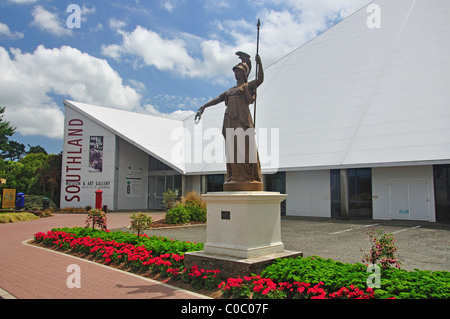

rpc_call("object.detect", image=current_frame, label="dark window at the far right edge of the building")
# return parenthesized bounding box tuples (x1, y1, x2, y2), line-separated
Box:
(433, 165, 450, 223)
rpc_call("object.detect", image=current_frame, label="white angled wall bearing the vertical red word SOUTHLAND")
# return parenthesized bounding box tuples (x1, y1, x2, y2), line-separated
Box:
(60, 107, 116, 208)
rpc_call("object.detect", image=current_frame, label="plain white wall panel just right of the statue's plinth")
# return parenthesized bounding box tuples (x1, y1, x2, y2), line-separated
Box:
(286, 170, 331, 217)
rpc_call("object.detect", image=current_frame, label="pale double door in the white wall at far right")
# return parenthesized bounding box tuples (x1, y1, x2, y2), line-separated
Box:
(389, 179, 430, 220)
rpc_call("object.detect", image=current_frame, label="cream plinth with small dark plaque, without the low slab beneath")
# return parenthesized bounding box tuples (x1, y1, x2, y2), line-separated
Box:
(202, 192, 286, 258)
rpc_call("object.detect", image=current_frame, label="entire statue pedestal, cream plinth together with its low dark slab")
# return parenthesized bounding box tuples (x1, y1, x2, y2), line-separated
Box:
(185, 191, 302, 276)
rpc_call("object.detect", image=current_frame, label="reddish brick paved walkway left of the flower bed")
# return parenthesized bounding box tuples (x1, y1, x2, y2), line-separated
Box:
(0, 213, 207, 299)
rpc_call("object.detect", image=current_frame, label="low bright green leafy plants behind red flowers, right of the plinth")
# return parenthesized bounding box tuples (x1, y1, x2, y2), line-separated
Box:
(261, 256, 450, 299)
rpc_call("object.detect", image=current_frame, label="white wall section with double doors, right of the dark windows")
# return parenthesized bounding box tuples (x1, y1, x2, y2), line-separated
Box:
(372, 165, 436, 222)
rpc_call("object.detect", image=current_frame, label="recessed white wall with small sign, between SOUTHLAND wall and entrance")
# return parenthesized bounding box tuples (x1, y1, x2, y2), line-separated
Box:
(116, 138, 149, 210)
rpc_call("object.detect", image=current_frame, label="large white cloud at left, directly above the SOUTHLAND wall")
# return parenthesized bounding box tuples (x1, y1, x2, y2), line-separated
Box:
(0, 45, 141, 138)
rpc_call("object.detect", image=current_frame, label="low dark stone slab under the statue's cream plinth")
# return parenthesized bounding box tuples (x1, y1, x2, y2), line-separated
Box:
(184, 250, 303, 279)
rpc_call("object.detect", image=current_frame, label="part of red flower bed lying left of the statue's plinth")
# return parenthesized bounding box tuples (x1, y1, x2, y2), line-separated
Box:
(34, 228, 220, 289)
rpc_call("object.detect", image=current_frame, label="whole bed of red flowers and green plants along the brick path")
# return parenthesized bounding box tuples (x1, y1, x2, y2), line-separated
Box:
(34, 227, 450, 299)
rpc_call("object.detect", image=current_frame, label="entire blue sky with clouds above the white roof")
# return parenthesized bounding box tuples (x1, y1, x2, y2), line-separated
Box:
(0, 0, 370, 154)
